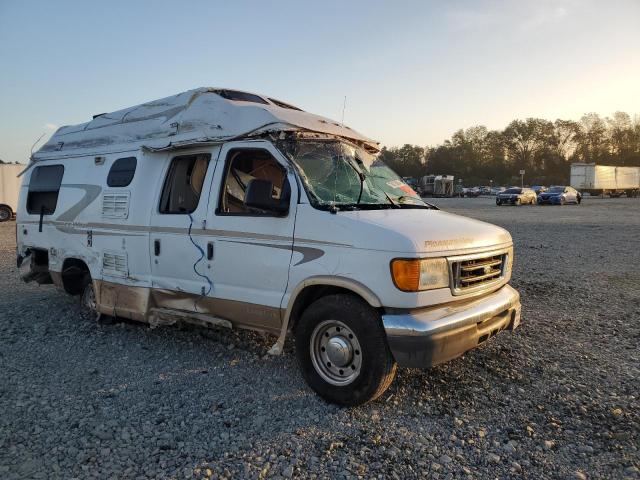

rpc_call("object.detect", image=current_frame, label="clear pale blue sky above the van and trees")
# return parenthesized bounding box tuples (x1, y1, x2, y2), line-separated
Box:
(0, 0, 640, 163)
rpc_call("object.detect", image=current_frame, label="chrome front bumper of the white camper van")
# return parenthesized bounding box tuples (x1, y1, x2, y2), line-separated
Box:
(382, 285, 520, 368)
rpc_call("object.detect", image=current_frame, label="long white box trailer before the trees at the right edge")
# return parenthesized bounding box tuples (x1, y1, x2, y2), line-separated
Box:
(570, 163, 640, 197)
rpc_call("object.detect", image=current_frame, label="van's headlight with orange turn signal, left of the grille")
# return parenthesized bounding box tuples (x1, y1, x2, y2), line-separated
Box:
(391, 258, 449, 292)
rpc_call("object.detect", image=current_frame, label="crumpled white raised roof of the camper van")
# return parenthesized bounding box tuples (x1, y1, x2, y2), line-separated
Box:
(34, 88, 379, 161)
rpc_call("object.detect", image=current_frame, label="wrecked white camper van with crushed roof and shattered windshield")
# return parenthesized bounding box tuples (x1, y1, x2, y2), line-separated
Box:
(17, 88, 520, 405)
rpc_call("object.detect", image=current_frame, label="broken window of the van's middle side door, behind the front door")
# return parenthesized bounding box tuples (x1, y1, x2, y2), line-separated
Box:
(160, 153, 211, 214)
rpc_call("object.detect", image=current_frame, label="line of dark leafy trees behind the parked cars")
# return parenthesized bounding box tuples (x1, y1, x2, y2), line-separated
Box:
(380, 112, 640, 185)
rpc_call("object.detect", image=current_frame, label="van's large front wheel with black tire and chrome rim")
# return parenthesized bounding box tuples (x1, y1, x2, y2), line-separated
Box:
(295, 294, 397, 406)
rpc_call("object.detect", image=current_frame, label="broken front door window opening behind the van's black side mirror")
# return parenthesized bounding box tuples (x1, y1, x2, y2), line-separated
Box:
(216, 149, 287, 215)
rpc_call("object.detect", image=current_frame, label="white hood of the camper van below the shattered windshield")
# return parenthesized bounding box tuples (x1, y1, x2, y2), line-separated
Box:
(320, 209, 512, 254)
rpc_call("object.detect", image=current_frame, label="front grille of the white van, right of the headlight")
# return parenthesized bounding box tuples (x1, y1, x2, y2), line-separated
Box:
(451, 253, 507, 293)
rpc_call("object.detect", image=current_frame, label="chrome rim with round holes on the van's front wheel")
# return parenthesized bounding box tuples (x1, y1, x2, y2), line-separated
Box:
(309, 320, 362, 386)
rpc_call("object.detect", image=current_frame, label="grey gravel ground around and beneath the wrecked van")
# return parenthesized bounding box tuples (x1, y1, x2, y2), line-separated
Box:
(0, 198, 640, 479)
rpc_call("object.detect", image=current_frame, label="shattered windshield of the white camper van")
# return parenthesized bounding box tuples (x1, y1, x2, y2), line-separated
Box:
(278, 140, 429, 209)
